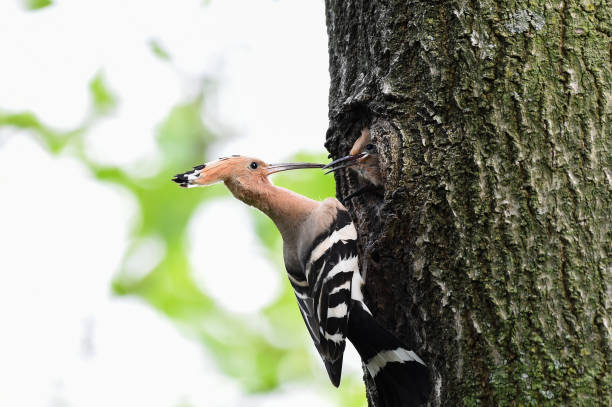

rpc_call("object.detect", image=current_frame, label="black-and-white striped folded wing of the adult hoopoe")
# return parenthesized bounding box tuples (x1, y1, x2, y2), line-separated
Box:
(296, 208, 361, 386)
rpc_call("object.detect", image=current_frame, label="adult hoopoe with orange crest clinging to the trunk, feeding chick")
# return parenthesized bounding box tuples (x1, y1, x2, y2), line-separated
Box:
(173, 156, 429, 407)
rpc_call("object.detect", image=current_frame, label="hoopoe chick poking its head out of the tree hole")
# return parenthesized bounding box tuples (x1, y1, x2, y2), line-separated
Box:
(323, 127, 383, 201)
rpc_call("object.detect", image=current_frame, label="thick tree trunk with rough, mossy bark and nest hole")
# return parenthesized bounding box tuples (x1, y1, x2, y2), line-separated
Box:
(326, 0, 612, 406)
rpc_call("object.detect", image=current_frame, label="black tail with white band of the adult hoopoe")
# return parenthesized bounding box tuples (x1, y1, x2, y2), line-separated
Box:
(348, 300, 430, 407)
